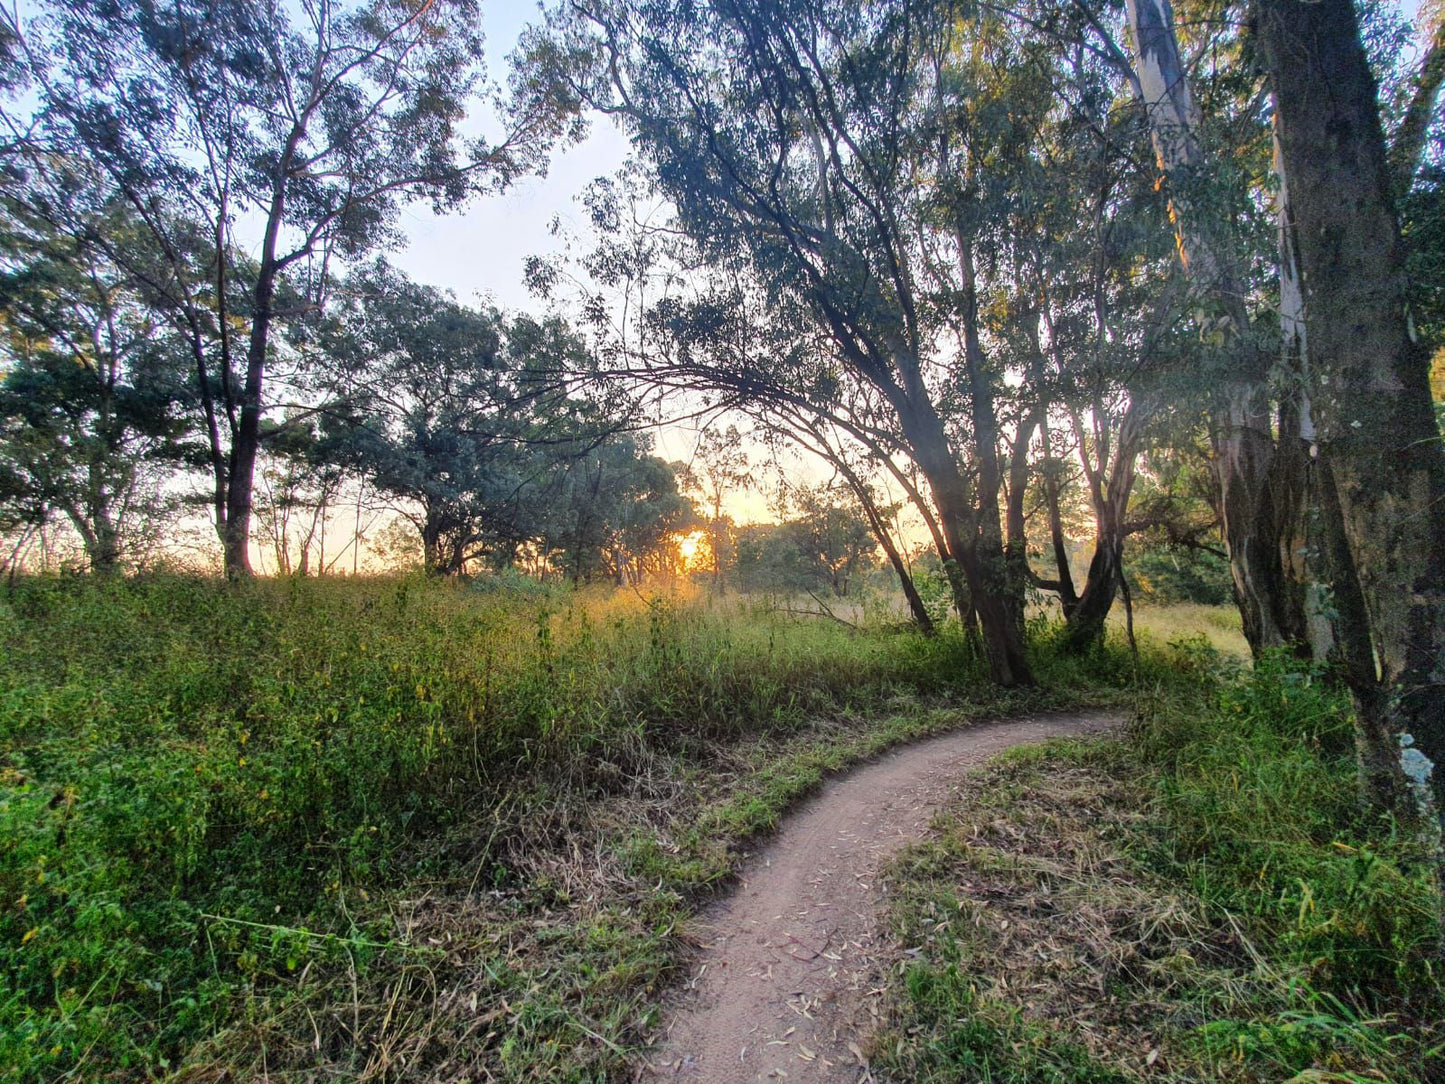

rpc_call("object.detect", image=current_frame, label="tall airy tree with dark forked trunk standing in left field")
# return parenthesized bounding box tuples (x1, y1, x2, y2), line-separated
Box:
(7, 0, 569, 575)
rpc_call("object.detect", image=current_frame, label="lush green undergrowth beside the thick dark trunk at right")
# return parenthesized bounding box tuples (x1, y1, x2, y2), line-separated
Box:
(1140, 653, 1439, 1007)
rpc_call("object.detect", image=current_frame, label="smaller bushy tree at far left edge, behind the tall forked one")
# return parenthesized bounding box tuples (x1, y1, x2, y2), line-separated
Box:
(0, 193, 194, 572)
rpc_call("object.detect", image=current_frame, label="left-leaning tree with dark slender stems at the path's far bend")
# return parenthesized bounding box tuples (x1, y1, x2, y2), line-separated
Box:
(530, 0, 1080, 685)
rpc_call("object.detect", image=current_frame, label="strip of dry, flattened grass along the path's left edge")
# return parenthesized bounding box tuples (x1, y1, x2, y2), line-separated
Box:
(174, 701, 1040, 1081)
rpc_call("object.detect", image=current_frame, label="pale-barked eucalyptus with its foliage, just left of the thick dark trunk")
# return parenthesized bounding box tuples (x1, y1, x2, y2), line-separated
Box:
(1094, 0, 1309, 653)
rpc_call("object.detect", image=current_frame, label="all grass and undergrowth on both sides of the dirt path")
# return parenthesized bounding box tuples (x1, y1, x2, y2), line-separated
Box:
(8, 577, 1445, 1083)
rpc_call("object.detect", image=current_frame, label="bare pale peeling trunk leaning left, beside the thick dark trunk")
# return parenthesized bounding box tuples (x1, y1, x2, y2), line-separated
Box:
(1129, 0, 1302, 655)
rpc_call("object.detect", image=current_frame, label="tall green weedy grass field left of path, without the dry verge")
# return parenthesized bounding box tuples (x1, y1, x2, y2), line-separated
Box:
(0, 577, 999, 1081)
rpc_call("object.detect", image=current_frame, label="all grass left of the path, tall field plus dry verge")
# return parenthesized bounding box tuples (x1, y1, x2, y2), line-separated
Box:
(0, 577, 1124, 1081)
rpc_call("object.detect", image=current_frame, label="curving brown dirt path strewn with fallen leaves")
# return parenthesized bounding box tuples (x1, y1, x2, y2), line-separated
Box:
(639, 714, 1117, 1084)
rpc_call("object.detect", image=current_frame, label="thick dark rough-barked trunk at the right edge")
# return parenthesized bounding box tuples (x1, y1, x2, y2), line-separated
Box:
(1257, 0, 1445, 830)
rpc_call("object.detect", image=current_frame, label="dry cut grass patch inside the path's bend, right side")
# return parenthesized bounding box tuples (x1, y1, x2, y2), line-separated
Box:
(874, 743, 1442, 1084)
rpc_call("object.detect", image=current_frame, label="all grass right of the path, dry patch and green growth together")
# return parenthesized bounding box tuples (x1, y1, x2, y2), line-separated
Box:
(876, 640, 1445, 1084)
